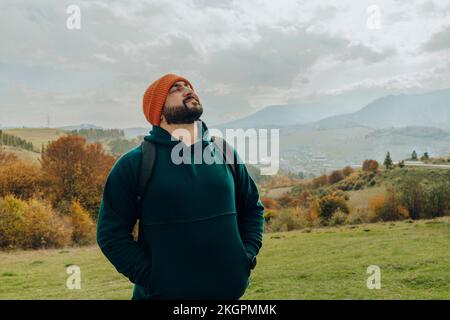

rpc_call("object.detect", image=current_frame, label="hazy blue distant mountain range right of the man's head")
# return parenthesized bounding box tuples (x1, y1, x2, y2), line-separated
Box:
(215, 88, 450, 129)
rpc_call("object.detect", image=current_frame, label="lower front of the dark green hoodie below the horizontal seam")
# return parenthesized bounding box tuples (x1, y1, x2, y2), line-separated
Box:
(139, 213, 250, 299)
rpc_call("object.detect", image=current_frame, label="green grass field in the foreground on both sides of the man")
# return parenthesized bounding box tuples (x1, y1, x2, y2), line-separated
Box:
(0, 217, 450, 299)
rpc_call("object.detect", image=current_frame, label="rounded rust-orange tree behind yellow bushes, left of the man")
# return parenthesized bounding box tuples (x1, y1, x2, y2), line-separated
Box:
(40, 135, 115, 218)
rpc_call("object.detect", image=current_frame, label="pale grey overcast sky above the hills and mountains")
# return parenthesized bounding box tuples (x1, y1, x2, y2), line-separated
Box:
(0, 0, 450, 128)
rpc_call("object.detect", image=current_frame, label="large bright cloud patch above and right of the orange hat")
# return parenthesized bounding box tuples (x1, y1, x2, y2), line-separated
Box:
(195, 27, 394, 88)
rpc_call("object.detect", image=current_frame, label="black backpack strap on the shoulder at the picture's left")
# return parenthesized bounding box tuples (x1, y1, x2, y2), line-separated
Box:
(136, 140, 156, 218)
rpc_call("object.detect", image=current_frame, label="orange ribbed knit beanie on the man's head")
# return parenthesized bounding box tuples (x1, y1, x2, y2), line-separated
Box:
(142, 73, 194, 126)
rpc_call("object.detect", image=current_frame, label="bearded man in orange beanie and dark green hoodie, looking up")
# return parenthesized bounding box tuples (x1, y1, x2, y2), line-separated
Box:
(97, 74, 264, 299)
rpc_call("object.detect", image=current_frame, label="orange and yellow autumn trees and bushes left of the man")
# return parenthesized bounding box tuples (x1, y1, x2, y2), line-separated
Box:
(0, 135, 117, 249)
